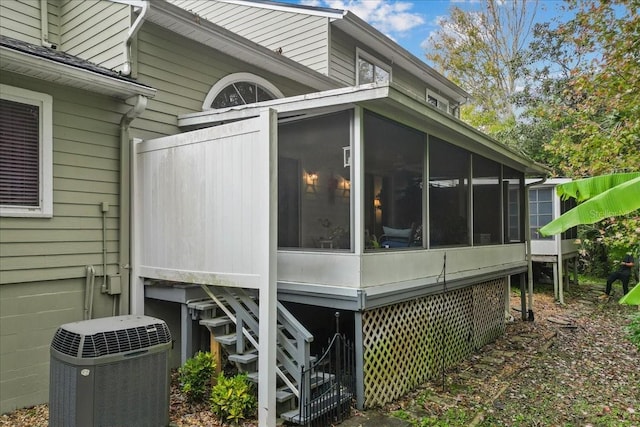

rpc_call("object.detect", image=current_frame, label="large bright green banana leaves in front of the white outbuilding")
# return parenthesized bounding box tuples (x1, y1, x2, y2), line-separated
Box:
(540, 173, 640, 236)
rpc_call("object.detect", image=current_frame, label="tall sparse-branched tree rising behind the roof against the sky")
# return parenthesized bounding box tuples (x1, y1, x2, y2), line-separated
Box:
(426, 0, 538, 130)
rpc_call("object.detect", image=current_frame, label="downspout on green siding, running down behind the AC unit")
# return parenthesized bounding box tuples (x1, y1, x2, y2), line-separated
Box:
(118, 95, 147, 314)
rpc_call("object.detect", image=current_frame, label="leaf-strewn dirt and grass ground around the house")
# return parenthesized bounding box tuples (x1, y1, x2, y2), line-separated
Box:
(0, 285, 640, 427)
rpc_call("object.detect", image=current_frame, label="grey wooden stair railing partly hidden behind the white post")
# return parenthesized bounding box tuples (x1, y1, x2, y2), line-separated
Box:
(201, 285, 313, 398)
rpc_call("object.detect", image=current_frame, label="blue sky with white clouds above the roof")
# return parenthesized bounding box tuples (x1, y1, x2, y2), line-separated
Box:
(276, 0, 562, 64)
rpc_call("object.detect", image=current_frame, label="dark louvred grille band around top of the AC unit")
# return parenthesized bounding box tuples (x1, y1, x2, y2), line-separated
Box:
(51, 323, 171, 359)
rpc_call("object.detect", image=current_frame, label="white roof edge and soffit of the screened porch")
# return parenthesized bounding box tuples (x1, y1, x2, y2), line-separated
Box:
(178, 83, 550, 176)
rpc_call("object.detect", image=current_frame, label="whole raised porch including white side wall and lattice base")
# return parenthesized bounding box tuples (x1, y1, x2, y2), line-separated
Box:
(134, 84, 546, 414)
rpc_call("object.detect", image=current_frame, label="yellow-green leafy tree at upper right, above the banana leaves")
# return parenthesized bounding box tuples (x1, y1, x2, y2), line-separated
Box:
(536, 0, 640, 177)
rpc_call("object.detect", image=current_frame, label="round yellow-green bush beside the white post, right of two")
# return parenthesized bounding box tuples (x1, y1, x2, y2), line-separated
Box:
(211, 374, 257, 423)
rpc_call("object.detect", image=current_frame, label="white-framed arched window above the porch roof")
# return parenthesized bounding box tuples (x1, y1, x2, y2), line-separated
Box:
(202, 73, 284, 111)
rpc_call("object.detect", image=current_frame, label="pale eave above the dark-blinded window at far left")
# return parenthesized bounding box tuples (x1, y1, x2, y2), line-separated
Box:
(0, 46, 156, 99)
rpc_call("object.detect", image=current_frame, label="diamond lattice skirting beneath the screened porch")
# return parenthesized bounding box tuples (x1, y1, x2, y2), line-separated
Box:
(362, 279, 506, 408)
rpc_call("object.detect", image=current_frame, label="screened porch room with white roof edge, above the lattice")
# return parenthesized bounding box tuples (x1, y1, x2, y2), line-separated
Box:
(172, 84, 546, 300)
